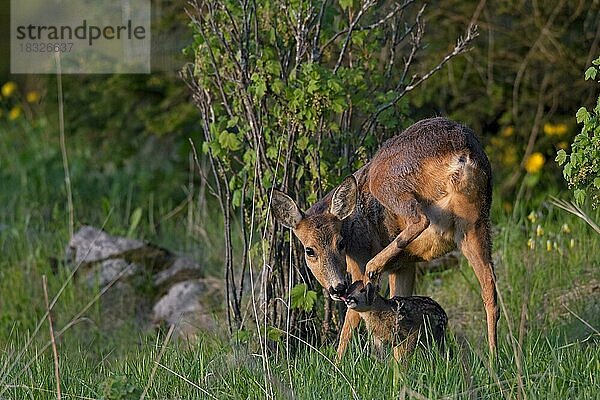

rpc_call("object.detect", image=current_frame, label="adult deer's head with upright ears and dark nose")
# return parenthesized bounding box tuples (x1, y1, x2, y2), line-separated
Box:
(271, 175, 358, 300)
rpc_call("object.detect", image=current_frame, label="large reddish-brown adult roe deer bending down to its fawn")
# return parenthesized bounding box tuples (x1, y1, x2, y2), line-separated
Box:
(272, 118, 499, 357)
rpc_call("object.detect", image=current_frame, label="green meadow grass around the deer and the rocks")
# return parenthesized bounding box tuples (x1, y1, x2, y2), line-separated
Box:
(0, 115, 600, 399)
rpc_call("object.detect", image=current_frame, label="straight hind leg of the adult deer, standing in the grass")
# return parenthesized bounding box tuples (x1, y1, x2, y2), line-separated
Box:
(460, 219, 500, 355)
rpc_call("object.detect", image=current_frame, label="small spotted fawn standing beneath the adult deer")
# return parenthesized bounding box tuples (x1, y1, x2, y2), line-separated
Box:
(343, 281, 448, 361)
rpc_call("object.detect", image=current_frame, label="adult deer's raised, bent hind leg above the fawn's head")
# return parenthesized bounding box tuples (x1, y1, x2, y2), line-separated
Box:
(365, 195, 429, 284)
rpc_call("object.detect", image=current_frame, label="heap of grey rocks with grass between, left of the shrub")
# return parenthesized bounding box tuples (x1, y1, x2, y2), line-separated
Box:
(66, 226, 223, 340)
